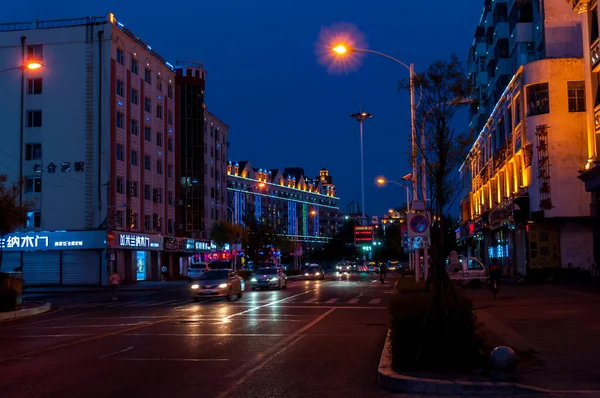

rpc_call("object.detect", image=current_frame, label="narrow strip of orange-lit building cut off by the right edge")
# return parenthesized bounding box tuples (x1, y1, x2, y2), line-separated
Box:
(566, 0, 600, 264)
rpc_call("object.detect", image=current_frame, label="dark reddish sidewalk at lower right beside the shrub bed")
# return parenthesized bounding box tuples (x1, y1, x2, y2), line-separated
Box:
(465, 285, 600, 396)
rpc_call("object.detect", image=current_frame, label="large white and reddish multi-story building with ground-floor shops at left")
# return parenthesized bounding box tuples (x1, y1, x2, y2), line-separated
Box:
(0, 14, 193, 284)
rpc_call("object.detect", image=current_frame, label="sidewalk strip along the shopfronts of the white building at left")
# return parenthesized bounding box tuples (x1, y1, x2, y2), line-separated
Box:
(23, 279, 189, 296)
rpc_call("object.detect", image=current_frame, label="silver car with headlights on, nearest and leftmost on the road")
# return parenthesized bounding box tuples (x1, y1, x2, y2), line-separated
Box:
(190, 269, 245, 301)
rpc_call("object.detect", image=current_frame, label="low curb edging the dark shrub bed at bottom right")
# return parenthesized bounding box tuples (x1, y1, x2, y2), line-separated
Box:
(377, 329, 549, 396)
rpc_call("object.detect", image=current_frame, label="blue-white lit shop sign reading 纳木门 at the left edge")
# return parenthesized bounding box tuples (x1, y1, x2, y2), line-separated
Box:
(0, 231, 106, 251)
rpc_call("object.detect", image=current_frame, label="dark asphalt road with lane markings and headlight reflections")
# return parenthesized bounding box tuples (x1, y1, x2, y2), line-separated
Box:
(0, 274, 404, 398)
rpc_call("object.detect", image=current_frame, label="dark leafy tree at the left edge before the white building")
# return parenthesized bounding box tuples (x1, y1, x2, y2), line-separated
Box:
(0, 174, 33, 267)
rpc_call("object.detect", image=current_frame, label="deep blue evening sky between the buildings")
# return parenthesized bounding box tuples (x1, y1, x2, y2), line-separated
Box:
(0, 0, 483, 214)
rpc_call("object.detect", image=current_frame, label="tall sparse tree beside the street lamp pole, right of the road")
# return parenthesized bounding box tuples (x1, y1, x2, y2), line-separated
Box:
(400, 55, 476, 305)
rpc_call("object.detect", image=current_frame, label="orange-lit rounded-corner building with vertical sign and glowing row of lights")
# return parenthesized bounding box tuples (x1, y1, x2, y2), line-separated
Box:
(460, 58, 593, 275)
